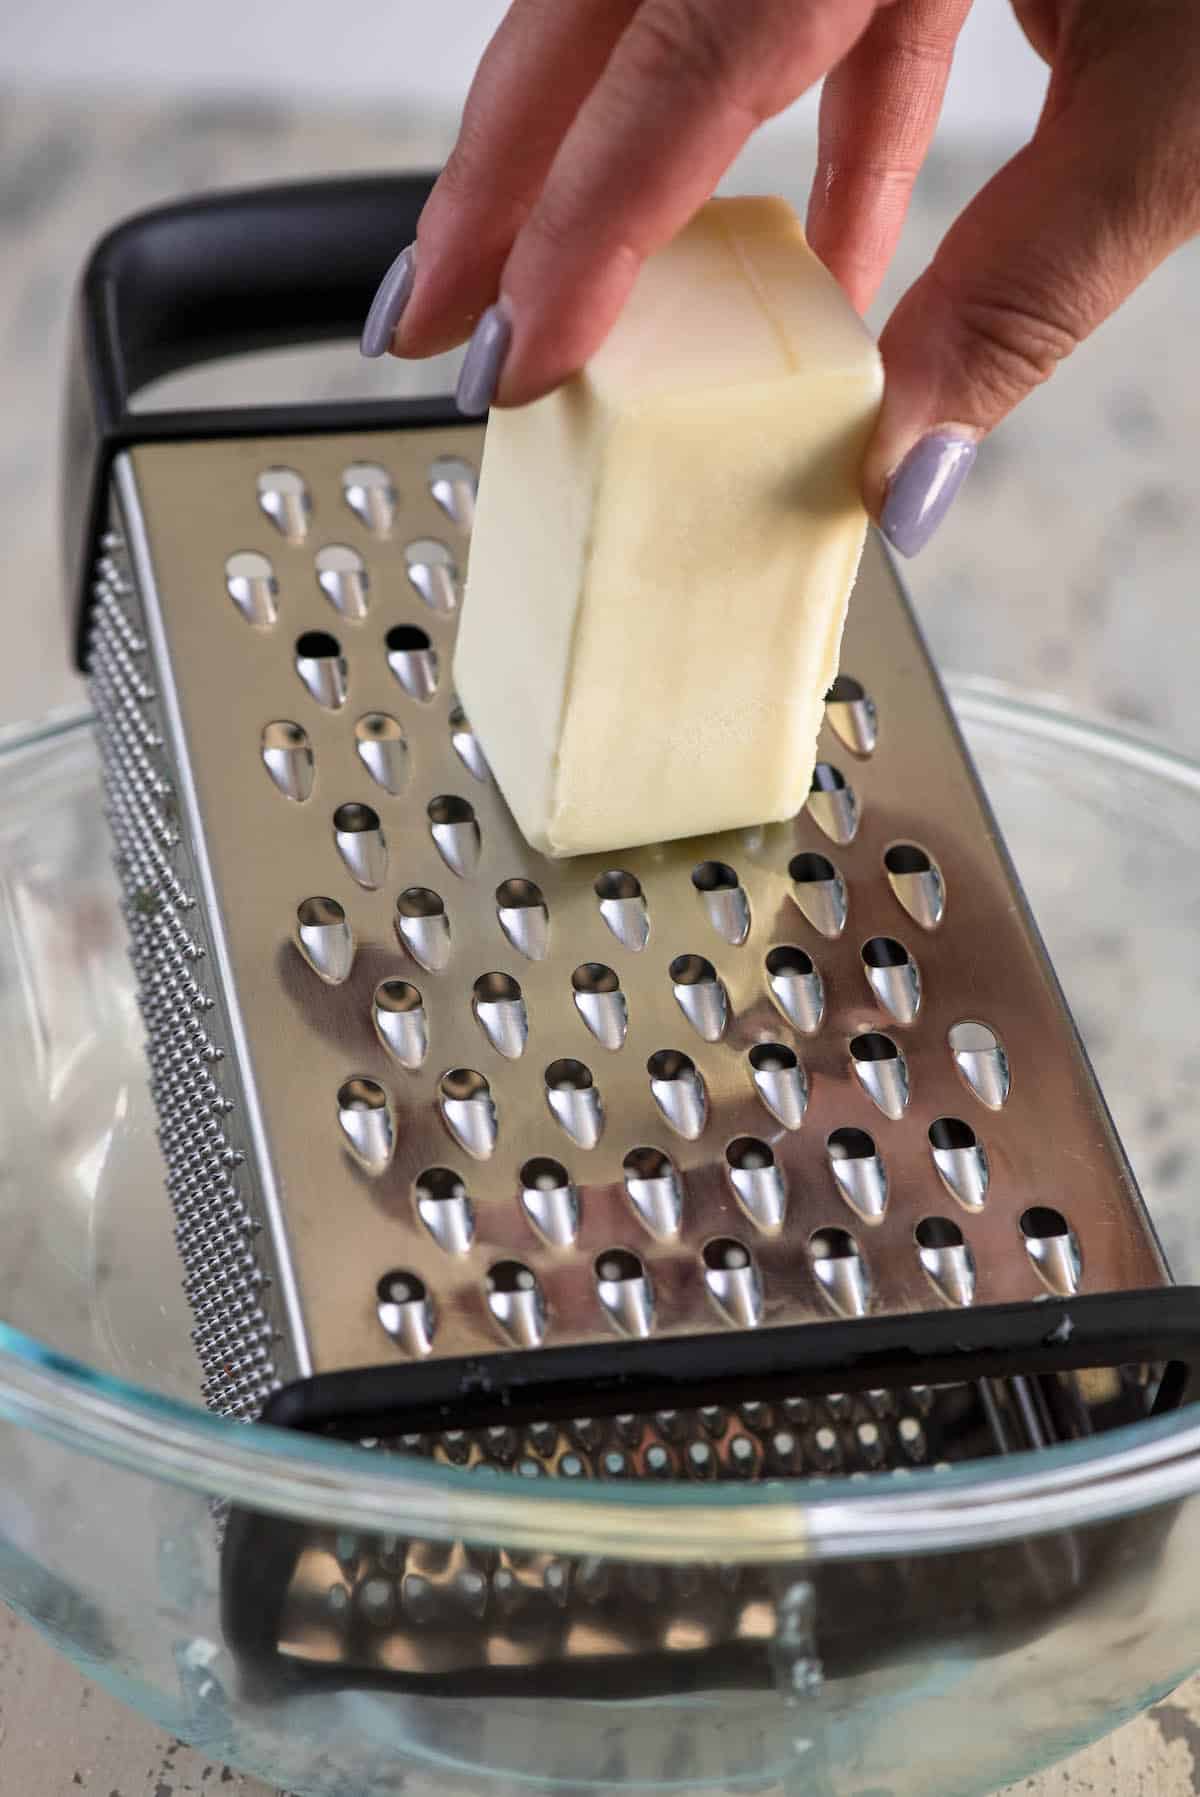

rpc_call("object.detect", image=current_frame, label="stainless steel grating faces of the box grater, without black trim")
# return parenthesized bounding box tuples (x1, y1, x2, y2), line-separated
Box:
(93, 428, 1164, 1414)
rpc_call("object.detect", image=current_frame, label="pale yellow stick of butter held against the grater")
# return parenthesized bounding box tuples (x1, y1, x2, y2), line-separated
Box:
(454, 199, 884, 855)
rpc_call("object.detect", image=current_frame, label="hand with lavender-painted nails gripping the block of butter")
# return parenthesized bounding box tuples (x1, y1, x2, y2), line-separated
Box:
(363, 0, 1200, 555)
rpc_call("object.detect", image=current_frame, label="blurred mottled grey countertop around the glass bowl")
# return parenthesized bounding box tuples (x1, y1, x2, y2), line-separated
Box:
(0, 92, 1200, 1797)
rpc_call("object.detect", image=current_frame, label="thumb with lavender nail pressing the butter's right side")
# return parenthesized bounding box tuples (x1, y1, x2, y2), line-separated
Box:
(864, 29, 1200, 555)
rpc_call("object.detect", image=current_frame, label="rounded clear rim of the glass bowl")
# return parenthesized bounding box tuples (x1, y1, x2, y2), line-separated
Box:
(0, 693, 1200, 1563)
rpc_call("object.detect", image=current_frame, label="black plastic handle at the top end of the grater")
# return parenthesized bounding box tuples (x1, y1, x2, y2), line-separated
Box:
(61, 174, 446, 667)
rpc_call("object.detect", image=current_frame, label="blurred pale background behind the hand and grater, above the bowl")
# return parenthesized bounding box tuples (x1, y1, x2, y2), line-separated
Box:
(0, 0, 1200, 749)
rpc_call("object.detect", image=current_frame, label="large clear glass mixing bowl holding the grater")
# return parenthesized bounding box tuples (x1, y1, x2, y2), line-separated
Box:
(0, 683, 1200, 1797)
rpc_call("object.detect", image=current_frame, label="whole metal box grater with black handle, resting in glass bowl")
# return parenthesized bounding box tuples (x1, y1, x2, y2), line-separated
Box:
(65, 180, 1196, 1691)
